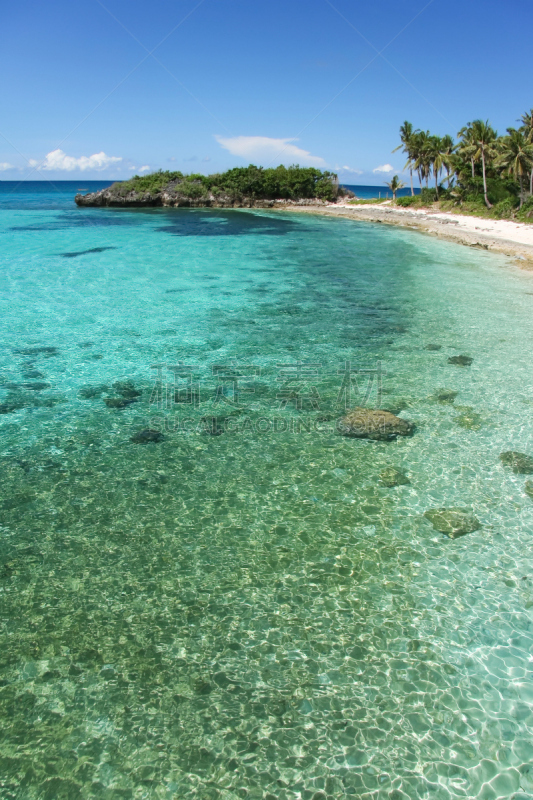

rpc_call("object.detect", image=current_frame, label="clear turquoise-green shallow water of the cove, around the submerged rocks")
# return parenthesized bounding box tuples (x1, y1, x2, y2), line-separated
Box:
(0, 184, 533, 800)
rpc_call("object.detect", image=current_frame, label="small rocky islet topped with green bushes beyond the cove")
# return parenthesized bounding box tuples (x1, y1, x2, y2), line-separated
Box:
(75, 164, 354, 208)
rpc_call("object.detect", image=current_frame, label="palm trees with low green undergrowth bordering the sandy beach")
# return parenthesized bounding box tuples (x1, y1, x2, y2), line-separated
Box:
(388, 109, 533, 222)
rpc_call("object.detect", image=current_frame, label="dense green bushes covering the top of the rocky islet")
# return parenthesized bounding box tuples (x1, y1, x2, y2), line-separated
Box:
(112, 164, 345, 202)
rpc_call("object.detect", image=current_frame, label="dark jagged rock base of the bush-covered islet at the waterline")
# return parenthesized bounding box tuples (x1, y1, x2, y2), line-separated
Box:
(74, 186, 344, 208)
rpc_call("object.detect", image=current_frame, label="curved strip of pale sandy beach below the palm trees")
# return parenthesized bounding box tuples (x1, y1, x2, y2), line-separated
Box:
(286, 203, 533, 271)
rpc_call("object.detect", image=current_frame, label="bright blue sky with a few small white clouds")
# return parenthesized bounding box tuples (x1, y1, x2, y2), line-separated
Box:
(0, 0, 533, 184)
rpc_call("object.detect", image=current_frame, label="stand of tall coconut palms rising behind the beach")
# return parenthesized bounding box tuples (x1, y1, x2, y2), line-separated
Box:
(388, 114, 533, 209)
